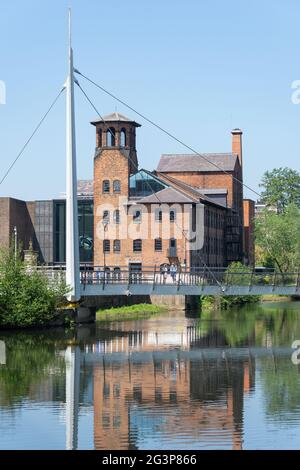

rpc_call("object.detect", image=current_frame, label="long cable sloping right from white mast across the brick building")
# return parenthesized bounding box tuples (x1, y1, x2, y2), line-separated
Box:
(74, 69, 261, 198)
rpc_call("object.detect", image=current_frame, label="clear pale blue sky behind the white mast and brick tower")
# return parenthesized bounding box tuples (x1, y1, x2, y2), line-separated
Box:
(0, 0, 300, 199)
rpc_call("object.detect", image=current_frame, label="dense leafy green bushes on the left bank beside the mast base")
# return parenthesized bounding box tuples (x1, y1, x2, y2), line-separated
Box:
(0, 249, 68, 328)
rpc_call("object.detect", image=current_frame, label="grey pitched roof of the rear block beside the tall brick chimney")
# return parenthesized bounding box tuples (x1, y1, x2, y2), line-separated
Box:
(157, 153, 238, 173)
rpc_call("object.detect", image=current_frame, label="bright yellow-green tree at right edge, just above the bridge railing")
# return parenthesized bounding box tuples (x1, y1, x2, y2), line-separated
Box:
(255, 204, 300, 273)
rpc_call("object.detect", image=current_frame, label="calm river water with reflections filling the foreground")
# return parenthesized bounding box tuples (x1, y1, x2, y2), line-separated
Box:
(0, 302, 300, 450)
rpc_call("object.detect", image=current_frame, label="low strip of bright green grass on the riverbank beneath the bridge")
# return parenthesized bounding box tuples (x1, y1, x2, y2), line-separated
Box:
(96, 304, 168, 321)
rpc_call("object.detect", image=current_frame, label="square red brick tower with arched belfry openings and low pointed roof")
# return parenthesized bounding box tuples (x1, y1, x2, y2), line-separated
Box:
(91, 112, 140, 266)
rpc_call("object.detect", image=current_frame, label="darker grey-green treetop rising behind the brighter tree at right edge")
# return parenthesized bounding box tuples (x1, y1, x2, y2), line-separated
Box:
(260, 168, 300, 212)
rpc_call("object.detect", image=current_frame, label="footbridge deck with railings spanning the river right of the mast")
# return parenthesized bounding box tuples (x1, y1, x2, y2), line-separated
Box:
(35, 267, 300, 297)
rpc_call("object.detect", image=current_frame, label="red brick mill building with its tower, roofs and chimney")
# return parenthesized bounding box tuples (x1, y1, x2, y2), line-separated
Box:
(92, 113, 252, 271)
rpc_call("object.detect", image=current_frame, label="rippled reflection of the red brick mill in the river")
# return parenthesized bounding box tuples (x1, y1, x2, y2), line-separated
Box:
(88, 329, 254, 449)
